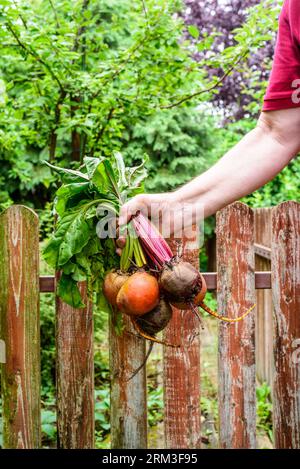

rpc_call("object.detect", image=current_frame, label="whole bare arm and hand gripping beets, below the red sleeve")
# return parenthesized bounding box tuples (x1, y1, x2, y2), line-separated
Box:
(118, 107, 300, 247)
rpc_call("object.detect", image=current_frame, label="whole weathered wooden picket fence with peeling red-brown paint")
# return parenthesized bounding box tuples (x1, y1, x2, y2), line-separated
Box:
(0, 202, 300, 448)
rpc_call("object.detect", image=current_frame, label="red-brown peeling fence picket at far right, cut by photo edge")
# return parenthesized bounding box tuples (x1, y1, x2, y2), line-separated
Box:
(272, 201, 300, 449)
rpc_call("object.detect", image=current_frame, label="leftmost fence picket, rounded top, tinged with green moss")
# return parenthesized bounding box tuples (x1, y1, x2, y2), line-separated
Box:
(0, 205, 41, 449)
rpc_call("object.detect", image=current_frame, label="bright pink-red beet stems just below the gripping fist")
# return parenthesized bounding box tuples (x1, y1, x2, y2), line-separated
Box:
(132, 213, 173, 269)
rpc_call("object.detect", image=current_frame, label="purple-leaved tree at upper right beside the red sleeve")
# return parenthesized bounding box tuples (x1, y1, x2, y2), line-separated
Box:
(183, 0, 282, 120)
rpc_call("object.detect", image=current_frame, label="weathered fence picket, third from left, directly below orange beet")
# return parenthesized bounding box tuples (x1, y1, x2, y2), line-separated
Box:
(110, 314, 147, 449)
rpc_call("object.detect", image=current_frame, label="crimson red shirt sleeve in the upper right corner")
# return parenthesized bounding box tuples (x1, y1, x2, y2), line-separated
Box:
(263, 0, 300, 111)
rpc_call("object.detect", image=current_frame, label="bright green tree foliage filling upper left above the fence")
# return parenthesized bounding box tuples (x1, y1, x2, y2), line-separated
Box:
(0, 0, 277, 209)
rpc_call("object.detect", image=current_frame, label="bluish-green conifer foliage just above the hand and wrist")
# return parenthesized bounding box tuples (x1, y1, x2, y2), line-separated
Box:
(124, 108, 221, 192)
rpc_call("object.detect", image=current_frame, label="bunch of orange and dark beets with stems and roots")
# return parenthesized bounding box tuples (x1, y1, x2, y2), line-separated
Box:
(103, 213, 252, 345)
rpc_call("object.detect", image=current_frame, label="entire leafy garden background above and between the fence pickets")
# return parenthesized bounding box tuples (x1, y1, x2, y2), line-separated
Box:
(0, 0, 300, 448)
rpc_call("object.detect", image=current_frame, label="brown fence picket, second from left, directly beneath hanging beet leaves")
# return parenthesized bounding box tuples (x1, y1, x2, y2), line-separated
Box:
(56, 274, 94, 449)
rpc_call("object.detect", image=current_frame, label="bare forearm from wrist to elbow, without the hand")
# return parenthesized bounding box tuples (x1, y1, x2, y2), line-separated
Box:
(174, 118, 299, 217)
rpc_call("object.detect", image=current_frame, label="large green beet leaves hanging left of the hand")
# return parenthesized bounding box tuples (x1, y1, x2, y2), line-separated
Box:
(43, 152, 147, 308)
